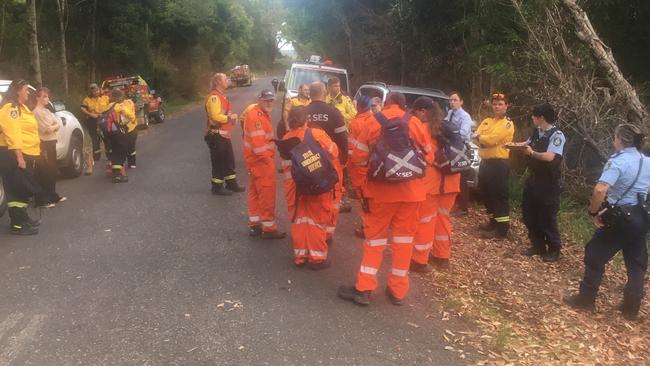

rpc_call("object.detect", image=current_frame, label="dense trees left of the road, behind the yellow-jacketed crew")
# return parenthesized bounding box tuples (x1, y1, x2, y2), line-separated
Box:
(0, 0, 282, 97)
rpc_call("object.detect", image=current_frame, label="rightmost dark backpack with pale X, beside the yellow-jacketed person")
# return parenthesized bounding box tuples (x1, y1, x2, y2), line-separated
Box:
(434, 122, 474, 175)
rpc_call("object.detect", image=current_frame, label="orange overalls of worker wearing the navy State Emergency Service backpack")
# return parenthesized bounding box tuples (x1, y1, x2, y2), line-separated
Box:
(283, 127, 339, 265)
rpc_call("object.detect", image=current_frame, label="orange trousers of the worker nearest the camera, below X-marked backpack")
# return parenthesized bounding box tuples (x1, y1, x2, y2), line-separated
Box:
(356, 200, 420, 299)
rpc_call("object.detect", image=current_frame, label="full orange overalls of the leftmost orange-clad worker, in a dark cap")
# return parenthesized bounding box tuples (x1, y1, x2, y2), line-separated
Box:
(244, 106, 277, 232)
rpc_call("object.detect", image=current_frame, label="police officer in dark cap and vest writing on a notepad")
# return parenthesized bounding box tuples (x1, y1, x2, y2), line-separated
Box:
(506, 103, 566, 262)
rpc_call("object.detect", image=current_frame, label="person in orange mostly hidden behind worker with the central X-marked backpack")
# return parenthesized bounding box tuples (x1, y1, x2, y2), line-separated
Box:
(348, 95, 373, 239)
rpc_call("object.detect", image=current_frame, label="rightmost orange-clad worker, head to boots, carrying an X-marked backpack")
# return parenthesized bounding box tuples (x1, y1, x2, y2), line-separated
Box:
(410, 97, 461, 273)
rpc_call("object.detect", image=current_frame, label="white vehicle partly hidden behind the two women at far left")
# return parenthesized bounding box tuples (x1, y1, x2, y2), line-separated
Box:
(0, 80, 84, 216)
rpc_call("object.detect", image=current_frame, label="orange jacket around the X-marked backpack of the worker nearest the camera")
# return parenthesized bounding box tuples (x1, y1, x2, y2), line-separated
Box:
(352, 105, 433, 203)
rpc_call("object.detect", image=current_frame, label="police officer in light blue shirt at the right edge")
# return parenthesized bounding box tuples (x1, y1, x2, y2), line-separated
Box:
(564, 124, 650, 320)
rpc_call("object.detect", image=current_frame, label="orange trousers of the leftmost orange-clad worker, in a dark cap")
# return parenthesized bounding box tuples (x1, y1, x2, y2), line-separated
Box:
(248, 161, 278, 232)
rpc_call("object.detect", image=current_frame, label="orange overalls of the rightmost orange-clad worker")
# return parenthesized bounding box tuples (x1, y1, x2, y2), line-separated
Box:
(413, 130, 460, 264)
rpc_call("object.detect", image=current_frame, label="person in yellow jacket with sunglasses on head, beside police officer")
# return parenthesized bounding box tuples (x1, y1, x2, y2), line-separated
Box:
(472, 93, 515, 239)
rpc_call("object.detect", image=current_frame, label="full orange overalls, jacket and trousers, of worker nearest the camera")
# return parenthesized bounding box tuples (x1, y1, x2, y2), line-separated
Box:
(353, 105, 433, 299)
